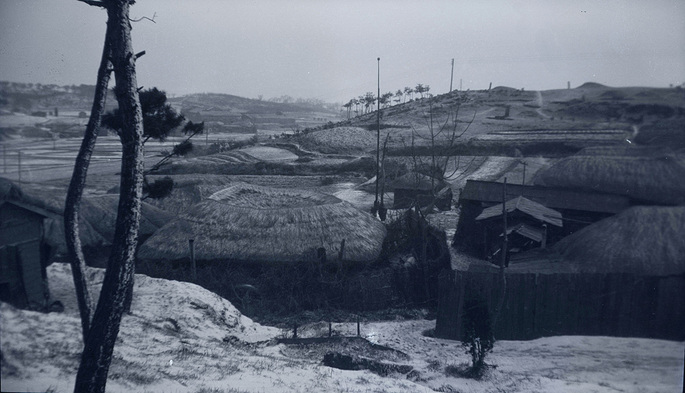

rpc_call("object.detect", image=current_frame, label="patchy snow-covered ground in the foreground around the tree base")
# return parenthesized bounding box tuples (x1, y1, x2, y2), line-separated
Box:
(0, 263, 685, 393)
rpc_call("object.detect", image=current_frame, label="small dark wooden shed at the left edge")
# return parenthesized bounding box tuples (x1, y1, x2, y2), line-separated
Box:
(0, 200, 51, 309)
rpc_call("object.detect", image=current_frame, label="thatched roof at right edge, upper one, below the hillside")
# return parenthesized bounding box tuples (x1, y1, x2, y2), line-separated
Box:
(535, 150, 685, 205)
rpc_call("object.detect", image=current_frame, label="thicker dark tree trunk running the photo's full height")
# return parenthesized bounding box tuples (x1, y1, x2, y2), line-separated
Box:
(74, 0, 143, 392)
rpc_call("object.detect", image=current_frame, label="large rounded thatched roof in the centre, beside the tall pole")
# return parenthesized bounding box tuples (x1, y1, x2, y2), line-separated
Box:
(138, 183, 386, 262)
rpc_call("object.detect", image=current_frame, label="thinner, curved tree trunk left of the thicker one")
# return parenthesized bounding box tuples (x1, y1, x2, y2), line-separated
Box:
(64, 14, 112, 342)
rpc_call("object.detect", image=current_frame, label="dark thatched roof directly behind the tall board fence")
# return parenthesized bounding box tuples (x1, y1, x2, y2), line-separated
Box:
(553, 206, 685, 275)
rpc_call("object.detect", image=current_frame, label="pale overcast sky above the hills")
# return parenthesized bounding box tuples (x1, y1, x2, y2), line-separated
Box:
(0, 0, 685, 102)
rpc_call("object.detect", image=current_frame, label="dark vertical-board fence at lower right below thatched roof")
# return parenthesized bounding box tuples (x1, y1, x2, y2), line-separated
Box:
(435, 271, 685, 341)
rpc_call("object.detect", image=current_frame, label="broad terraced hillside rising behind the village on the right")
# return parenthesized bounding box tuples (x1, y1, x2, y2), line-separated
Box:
(292, 83, 685, 155)
